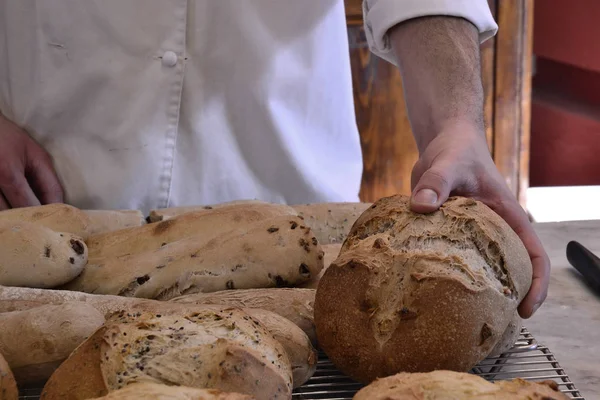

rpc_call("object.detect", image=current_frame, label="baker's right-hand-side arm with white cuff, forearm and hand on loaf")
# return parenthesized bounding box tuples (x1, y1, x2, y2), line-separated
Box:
(363, 0, 550, 318)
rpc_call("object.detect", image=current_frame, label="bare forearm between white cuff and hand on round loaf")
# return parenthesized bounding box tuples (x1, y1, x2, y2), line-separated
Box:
(390, 16, 484, 152)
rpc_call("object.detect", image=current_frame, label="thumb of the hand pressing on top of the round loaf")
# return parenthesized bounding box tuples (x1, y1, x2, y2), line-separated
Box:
(410, 168, 454, 213)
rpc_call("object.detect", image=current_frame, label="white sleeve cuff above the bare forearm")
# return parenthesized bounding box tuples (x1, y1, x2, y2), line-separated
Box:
(363, 0, 498, 64)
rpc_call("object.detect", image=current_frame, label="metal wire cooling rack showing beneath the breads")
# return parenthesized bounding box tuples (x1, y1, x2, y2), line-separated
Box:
(19, 328, 585, 400)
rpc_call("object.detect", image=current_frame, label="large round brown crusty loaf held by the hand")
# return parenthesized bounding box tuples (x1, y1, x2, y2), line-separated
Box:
(315, 195, 532, 383)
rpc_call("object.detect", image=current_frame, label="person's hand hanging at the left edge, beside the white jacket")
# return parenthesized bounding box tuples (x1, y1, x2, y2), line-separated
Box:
(0, 115, 63, 210)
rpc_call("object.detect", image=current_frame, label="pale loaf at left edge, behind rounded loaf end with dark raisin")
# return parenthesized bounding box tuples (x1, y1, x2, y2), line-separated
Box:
(0, 204, 91, 239)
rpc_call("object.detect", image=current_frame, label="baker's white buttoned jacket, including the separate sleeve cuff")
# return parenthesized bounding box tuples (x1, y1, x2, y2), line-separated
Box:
(0, 0, 497, 211)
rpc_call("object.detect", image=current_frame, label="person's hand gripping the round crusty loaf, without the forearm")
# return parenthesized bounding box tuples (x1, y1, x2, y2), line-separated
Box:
(411, 125, 550, 318)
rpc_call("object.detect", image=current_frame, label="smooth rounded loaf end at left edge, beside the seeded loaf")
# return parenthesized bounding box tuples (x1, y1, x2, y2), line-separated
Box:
(0, 303, 104, 384)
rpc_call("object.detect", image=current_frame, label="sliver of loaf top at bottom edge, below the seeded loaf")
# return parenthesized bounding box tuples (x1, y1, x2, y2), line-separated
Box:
(88, 382, 255, 400)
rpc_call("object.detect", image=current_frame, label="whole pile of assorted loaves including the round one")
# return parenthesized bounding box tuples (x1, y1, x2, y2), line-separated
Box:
(0, 196, 560, 400)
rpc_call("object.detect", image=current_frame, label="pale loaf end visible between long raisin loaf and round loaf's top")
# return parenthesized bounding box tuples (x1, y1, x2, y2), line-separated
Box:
(293, 203, 371, 244)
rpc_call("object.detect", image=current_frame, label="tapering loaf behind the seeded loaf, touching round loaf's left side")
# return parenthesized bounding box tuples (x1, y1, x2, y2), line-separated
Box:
(171, 288, 317, 346)
